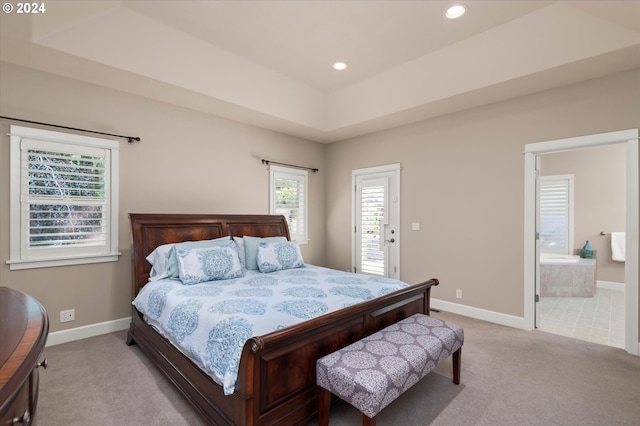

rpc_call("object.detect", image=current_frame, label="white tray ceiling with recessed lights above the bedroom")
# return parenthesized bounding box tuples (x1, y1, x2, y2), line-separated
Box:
(0, 0, 640, 142)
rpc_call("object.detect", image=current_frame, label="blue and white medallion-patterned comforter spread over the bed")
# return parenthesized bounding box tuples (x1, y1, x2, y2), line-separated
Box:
(132, 265, 407, 395)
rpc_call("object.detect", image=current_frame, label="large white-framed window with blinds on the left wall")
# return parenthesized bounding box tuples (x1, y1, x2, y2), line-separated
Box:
(7, 126, 120, 269)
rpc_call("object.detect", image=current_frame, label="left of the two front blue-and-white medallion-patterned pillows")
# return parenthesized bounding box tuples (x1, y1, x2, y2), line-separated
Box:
(176, 241, 247, 285)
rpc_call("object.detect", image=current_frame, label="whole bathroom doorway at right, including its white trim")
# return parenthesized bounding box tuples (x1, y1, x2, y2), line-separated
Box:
(525, 129, 639, 355)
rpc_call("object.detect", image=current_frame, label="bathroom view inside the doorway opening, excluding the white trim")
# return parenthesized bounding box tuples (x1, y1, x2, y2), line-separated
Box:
(536, 144, 626, 348)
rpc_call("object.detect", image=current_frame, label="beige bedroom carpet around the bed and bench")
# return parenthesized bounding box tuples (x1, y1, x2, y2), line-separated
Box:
(37, 312, 640, 426)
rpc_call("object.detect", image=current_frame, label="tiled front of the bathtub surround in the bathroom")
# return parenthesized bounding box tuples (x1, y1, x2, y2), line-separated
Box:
(540, 259, 596, 297)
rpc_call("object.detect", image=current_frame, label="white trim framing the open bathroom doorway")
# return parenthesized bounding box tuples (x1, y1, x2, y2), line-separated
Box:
(524, 129, 640, 355)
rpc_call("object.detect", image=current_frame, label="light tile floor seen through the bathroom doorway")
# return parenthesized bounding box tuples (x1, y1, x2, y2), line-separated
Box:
(538, 288, 625, 348)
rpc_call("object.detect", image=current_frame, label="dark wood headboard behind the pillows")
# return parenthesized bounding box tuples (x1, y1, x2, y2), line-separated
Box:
(129, 213, 290, 297)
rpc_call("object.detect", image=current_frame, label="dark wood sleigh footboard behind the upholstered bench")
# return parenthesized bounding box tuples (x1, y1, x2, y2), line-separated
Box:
(240, 279, 438, 425)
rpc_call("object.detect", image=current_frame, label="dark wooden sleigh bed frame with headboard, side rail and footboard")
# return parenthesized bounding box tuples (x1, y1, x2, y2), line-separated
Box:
(127, 214, 438, 426)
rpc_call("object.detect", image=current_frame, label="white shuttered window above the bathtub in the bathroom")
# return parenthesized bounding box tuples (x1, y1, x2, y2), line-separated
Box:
(540, 175, 573, 254)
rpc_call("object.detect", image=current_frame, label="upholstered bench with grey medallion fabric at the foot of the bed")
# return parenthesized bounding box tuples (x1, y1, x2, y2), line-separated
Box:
(316, 314, 464, 426)
